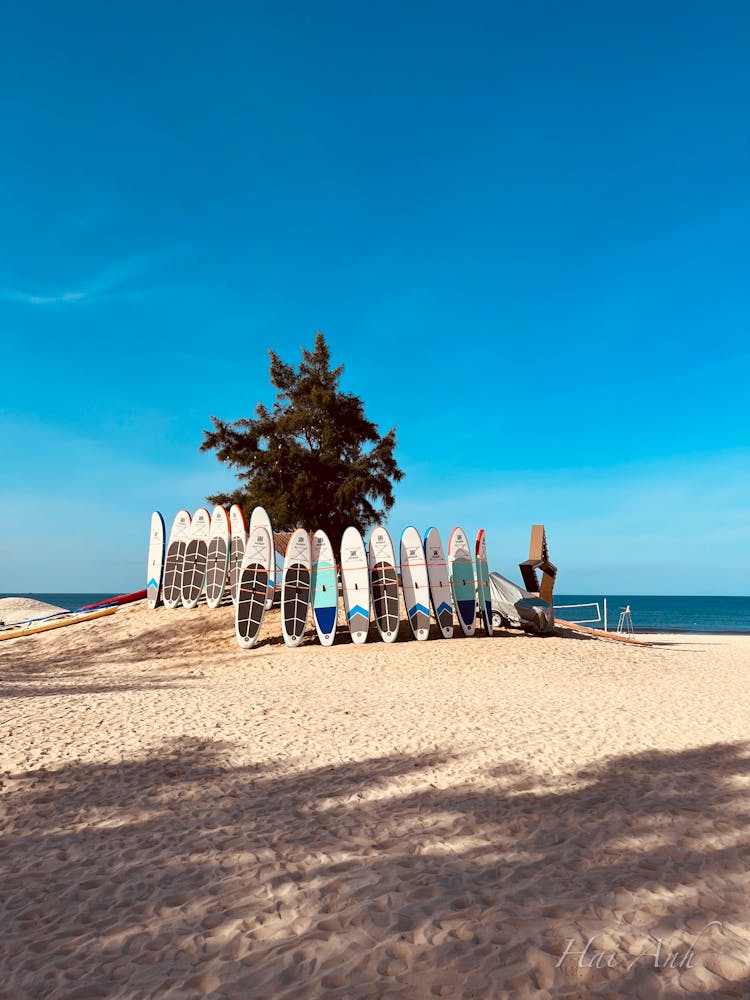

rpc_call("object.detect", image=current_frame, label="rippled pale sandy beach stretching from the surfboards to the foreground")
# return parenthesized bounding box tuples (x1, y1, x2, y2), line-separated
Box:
(0, 604, 750, 1000)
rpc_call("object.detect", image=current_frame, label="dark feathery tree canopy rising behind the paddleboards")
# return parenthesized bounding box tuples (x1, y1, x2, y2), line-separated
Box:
(201, 331, 404, 546)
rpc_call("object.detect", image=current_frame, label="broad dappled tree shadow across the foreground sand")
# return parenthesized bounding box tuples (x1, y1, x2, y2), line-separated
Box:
(0, 740, 750, 1000)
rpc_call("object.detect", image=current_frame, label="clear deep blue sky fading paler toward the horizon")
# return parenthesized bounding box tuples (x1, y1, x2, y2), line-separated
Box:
(0, 0, 750, 594)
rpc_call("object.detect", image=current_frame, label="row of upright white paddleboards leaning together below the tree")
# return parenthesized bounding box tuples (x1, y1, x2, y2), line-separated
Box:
(146, 504, 492, 649)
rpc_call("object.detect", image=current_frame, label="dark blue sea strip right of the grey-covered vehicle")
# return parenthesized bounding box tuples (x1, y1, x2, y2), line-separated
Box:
(555, 594, 750, 633)
